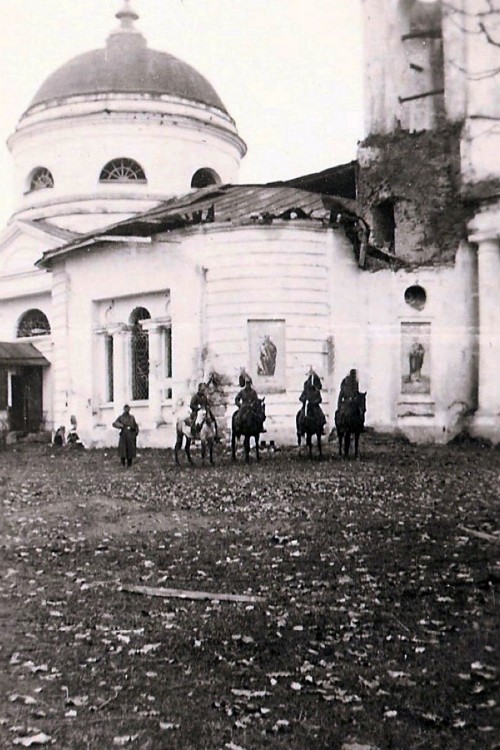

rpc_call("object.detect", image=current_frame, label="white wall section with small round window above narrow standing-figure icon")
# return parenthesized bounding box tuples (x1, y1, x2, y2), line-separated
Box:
(366, 244, 477, 442)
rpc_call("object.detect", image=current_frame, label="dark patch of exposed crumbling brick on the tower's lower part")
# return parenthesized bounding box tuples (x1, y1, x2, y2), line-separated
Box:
(357, 125, 473, 265)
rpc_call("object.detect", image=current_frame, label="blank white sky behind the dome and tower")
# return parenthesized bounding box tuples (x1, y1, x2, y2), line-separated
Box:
(0, 0, 363, 224)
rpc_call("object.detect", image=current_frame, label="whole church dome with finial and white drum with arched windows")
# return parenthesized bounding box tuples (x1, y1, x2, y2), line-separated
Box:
(8, 4, 246, 229)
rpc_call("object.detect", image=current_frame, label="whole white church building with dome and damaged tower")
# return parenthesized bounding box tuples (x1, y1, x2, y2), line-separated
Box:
(0, 0, 500, 447)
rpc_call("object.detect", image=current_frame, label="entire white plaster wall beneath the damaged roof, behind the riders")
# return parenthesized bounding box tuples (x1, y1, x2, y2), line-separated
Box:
(32, 222, 477, 447)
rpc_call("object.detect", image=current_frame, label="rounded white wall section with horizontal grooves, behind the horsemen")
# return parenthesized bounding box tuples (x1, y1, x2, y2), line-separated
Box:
(184, 222, 365, 444)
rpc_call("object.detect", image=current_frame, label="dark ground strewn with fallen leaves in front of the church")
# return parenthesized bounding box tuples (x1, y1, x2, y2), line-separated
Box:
(0, 435, 500, 750)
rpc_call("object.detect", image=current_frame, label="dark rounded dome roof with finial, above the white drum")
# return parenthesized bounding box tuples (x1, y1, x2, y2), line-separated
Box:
(28, 3, 227, 113)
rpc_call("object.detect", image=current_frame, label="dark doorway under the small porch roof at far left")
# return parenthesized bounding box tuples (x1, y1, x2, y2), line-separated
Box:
(10, 367, 43, 433)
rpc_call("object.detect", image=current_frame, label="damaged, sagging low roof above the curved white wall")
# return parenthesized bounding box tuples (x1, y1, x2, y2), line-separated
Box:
(37, 183, 356, 266)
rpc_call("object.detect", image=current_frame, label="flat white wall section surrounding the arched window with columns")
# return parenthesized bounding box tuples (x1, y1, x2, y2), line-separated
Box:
(56, 242, 203, 447)
